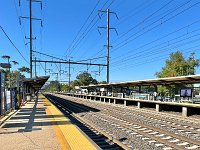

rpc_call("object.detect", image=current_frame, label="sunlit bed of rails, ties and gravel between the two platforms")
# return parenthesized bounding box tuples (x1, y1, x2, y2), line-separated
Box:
(45, 95, 200, 150)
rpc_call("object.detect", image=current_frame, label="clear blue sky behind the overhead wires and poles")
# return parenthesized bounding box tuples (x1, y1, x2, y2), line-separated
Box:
(0, 0, 200, 82)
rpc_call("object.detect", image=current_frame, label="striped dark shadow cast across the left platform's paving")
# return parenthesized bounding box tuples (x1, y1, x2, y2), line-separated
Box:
(0, 99, 71, 134)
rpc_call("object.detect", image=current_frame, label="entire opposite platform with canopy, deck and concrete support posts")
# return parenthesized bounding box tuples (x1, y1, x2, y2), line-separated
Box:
(60, 75, 200, 117)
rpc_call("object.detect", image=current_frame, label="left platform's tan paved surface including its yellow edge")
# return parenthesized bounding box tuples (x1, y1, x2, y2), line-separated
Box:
(0, 95, 99, 150)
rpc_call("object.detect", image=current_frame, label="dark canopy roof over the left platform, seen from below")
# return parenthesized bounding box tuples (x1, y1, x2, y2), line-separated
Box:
(22, 76, 49, 91)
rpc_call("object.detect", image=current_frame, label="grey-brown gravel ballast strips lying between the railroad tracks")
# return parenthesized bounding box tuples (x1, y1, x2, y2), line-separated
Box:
(52, 95, 200, 150)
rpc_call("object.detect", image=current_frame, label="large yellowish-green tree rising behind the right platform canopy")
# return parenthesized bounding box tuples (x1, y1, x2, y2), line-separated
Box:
(155, 51, 200, 96)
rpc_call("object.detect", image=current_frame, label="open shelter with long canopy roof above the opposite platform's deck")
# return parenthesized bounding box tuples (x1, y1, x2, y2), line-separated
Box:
(81, 75, 200, 101)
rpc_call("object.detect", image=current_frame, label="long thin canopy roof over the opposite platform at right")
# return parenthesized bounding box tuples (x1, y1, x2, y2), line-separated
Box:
(81, 75, 200, 88)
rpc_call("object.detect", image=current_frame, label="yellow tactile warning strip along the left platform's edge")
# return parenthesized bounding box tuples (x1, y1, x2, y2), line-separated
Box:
(43, 96, 97, 150)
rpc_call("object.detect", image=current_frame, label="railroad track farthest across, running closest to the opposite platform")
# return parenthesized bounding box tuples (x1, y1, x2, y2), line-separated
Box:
(56, 94, 200, 138)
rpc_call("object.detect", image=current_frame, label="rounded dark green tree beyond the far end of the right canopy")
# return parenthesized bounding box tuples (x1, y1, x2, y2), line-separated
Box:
(76, 72, 98, 86)
